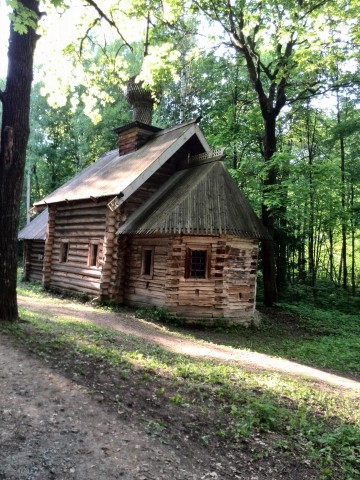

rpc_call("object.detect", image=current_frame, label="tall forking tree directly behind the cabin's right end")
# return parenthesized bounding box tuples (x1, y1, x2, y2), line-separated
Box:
(193, 0, 358, 306)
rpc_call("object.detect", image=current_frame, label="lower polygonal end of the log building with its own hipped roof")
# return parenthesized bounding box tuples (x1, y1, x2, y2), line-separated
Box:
(117, 155, 266, 322)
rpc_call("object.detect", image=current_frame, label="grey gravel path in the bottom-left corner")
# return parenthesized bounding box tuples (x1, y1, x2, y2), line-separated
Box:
(0, 335, 213, 480)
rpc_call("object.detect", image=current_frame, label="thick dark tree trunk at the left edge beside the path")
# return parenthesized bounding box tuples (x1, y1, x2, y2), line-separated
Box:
(0, 0, 39, 321)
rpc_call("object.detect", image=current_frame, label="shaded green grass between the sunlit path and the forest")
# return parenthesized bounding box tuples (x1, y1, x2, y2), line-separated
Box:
(147, 302, 360, 375)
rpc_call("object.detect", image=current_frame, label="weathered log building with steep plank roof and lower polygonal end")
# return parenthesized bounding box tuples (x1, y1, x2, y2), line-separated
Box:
(26, 83, 267, 322)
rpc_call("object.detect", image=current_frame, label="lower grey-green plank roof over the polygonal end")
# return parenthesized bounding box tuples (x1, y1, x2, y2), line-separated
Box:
(117, 161, 269, 239)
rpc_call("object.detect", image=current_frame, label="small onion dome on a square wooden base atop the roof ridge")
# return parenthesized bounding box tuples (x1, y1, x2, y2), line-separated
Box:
(114, 77, 161, 155)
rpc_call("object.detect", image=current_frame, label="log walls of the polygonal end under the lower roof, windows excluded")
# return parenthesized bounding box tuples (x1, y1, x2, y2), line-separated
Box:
(121, 235, 258, 322)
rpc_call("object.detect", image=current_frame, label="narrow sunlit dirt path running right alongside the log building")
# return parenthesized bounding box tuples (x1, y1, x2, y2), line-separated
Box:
(19, 296, 360, 392)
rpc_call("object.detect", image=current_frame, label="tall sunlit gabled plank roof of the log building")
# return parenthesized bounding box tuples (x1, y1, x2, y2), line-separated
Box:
(35, 120, 210, 207)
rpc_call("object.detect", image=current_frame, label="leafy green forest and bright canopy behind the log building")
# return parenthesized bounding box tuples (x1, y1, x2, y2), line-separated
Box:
(2, 0, 360, 310)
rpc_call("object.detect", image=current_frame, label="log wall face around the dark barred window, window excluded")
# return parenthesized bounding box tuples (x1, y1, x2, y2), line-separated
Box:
(165, 235, 258, 322)
